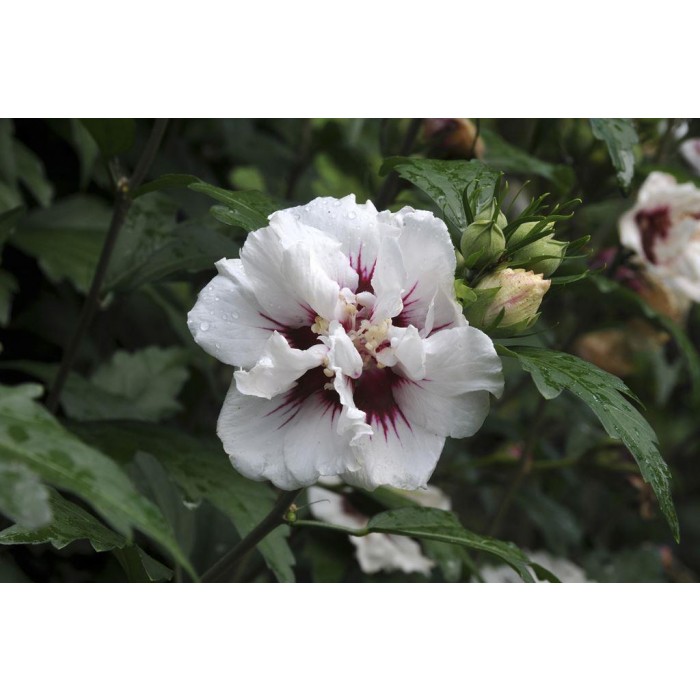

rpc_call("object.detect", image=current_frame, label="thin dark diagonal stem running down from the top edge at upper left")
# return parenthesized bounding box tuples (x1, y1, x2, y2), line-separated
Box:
(46, 119, 168, 413)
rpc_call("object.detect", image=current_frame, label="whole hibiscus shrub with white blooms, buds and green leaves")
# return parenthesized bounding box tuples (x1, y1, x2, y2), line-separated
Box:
(0, 119, 700, 582)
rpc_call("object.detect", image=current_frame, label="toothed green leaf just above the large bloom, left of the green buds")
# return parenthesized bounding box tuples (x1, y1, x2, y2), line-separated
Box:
(380, 156, 501, 231)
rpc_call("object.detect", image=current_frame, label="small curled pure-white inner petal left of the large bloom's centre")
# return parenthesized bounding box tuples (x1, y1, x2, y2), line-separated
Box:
(234, 331, 327, 399)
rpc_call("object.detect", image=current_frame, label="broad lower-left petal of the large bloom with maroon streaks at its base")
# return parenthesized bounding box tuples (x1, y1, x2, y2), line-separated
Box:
(217, 370, 358, 490)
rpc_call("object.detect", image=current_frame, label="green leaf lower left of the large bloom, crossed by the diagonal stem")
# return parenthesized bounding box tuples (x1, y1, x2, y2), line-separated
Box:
(74, 421, 294, 582)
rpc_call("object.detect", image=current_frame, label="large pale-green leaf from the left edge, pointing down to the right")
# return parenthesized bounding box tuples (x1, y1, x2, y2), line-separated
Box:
(0, 384, 194, 576)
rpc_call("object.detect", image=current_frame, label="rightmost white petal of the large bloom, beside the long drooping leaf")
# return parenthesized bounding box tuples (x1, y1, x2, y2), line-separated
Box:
(425, 326, 503, 397)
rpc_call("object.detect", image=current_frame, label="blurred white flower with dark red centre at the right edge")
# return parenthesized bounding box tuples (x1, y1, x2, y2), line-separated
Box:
(620, 172, 700, 302)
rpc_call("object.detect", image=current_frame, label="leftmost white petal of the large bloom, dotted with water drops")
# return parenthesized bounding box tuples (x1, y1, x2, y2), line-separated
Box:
(187, 259, 272, 367)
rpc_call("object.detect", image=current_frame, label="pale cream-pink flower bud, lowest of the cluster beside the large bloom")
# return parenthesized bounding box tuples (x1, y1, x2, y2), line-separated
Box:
(475, 268, 552, 332)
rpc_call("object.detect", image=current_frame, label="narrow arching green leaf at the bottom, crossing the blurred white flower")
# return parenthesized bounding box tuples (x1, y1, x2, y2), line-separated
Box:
(367, 507, 534, 583)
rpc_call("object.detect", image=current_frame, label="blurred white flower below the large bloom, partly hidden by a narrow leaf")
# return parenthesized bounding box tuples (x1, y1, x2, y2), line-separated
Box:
(308, 480, 450, 576)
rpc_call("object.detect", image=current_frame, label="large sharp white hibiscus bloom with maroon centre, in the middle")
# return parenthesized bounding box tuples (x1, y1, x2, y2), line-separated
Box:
(188, 195, 503, 490)
